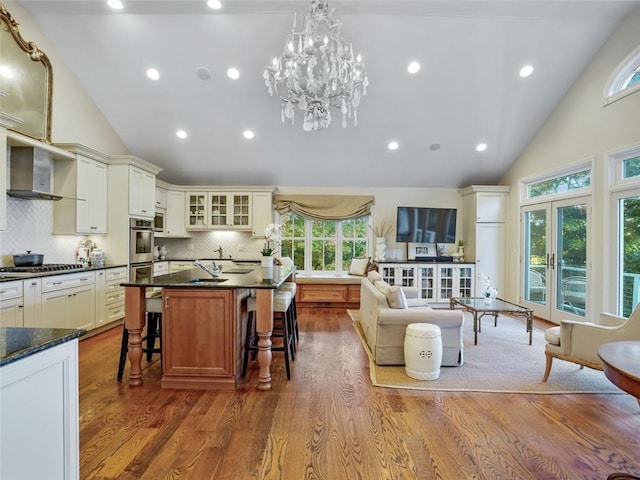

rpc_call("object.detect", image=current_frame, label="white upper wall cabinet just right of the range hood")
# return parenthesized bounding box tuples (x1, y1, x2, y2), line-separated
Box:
(53, 153, 108, 234)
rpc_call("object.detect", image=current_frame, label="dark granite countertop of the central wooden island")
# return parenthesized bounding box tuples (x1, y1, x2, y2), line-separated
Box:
(120, 266, 296, 290)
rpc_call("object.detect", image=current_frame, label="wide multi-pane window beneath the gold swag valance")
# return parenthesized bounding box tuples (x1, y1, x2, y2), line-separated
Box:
(281, 212, 369, 272)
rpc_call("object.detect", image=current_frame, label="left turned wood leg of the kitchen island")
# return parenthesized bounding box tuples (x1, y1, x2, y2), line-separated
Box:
(124, 287, 146, 387)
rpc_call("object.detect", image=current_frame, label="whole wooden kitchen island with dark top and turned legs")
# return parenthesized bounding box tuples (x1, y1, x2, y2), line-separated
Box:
(122, 266, 295, 390)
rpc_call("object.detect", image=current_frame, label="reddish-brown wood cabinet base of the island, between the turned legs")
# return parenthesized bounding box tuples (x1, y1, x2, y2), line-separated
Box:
(162, 288, 237, 390)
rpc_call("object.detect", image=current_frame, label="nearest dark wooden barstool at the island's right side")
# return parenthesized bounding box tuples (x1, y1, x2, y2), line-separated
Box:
(242, 290, 295, 380)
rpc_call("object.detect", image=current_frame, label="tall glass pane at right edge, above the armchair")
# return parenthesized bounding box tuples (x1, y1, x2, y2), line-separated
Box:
(618, 197, 640, 317)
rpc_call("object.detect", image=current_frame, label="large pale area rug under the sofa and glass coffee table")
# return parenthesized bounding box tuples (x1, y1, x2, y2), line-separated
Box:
(349, 310, 624, 394)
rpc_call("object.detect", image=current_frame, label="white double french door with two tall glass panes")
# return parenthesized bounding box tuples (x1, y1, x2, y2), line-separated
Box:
(520, 197, 590, 323)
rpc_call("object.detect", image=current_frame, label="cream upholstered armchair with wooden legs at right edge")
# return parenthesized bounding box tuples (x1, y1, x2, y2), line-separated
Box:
(542, 305, 640, 382)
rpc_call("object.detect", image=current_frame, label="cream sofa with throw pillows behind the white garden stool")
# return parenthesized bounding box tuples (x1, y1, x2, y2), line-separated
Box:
(360, 272, 464, 366)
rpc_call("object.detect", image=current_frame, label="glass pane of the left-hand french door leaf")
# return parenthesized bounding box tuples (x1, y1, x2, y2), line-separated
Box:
(524, 210, 547, 305)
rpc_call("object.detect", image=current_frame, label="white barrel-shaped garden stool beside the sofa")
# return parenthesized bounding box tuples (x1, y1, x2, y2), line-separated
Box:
(404, 323, 442, 380)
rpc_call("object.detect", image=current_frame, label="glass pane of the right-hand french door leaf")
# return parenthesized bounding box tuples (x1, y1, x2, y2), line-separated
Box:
(556, 203, 587, 317)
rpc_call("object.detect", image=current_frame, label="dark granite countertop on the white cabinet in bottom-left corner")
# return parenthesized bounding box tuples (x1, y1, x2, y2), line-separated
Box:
(0, 327, 87, 367)
